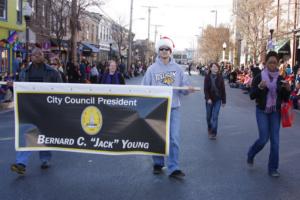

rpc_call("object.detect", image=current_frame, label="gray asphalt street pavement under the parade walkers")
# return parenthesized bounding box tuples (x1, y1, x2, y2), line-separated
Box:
(0, 74, 300, 200)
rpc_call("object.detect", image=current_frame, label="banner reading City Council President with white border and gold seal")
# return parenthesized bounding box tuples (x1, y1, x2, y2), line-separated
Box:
(14, 82, 173, 155)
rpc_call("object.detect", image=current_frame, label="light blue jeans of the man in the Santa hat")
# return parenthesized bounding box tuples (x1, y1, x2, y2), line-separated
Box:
(153, 108, 180, 174)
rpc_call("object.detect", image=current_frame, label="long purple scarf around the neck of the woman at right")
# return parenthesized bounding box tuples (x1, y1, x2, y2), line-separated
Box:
(261, 68, 279, 113)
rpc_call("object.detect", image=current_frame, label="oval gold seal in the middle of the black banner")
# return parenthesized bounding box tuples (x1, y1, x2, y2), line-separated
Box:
(81, 106, 103, 135)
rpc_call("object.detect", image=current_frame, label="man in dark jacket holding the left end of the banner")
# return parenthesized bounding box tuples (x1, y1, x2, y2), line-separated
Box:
(11, 48, 62, 174)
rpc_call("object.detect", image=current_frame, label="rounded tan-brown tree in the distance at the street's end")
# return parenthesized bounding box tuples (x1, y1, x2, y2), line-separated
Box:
(199, 25, 230, 63)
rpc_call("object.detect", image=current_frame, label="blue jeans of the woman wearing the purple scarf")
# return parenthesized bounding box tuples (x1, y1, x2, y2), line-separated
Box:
(248, 108, 281, 172)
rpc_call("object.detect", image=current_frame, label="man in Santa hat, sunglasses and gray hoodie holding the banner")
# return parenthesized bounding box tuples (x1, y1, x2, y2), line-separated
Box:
(142, 37, 195, 178)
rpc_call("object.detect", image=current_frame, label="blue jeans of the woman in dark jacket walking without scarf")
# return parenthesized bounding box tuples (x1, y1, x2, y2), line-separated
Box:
(206, 100, 222, 135)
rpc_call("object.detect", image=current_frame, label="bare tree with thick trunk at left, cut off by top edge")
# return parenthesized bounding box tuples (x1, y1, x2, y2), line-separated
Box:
(70, 0, 104, 63)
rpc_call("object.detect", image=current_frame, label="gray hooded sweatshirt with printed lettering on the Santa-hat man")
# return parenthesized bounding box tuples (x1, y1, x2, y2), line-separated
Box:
(142, 57, 190, 108)
